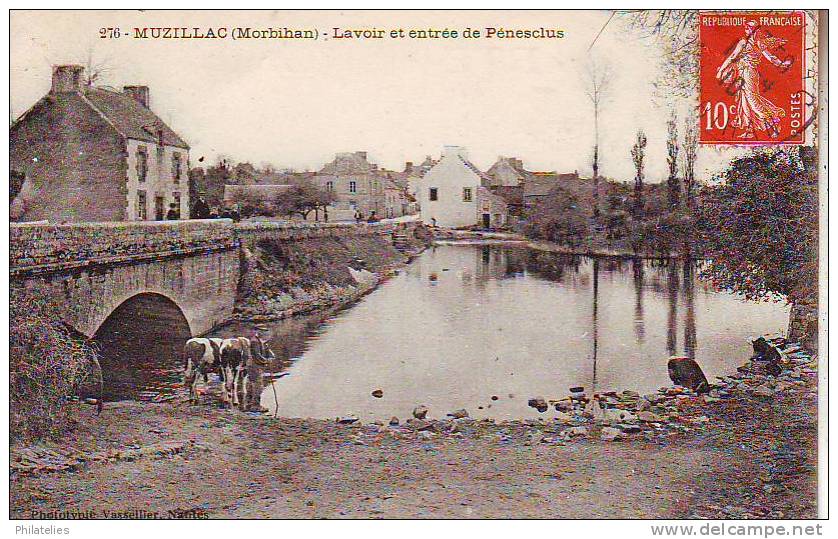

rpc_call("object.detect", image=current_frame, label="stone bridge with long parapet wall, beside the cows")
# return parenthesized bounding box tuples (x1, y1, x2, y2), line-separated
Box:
(10, 220, 410, 338)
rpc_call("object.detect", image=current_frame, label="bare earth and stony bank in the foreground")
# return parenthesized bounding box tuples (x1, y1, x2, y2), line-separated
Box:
(10, 338, 817, 518)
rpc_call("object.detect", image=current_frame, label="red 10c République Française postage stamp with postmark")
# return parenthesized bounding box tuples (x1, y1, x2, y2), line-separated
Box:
(699, 11, 805, 144)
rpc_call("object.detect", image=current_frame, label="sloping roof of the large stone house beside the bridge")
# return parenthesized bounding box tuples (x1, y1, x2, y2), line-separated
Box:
(83, 87, 189, 149)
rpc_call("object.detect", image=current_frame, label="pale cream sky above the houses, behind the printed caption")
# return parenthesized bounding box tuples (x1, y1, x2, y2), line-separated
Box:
(10, 11, 744, 182)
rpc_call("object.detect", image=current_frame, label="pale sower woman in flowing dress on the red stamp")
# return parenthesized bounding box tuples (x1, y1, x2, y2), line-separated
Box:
(716, 21, 791, 139)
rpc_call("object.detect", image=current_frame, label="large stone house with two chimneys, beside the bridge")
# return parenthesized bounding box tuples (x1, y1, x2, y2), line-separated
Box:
(9, 65, 189, 222)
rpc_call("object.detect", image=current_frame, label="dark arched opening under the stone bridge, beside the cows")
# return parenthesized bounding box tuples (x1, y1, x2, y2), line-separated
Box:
(92, 291, 192, 400)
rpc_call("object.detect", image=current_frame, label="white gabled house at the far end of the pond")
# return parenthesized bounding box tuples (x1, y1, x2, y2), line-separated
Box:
(417, 146, 507, 228)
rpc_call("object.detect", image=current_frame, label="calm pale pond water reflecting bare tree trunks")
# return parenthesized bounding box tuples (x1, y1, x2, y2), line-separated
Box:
(213, 243, 788, 421)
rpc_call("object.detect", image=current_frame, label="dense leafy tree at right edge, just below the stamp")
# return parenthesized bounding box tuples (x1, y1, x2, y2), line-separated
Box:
(697, 147, 818, 303)
